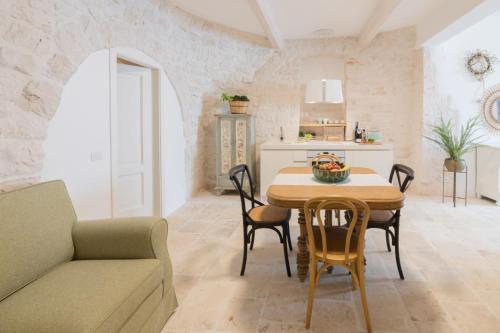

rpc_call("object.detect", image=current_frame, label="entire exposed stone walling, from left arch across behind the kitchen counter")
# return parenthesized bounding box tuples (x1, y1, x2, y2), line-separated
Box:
(0, 0, 434, 193)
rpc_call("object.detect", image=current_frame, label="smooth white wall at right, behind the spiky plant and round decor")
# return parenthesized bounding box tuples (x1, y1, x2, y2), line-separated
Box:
(422, 14, 500, 195)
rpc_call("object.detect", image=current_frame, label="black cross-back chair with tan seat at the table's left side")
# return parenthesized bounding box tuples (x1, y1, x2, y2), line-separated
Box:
(229, 164, 293, 277)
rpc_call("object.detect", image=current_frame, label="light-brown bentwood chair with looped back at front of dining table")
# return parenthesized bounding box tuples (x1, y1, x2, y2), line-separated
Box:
(304, 197, 371, 332)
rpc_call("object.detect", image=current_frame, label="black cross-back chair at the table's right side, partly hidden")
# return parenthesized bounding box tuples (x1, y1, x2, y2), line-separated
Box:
(367, 164, 415, 280)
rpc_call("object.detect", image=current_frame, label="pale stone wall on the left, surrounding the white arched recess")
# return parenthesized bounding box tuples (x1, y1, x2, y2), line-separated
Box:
(0, 0, 273, 192)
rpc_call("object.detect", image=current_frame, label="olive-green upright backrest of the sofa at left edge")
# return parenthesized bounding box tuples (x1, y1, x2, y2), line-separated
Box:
(0, 181, 76, 301)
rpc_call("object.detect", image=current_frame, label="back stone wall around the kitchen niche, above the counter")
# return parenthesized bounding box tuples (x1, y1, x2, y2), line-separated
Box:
(201, 28, 422, 190)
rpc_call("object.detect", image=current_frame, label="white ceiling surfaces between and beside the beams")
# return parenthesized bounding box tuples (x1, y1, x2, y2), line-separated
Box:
(171, 0, 443, 39)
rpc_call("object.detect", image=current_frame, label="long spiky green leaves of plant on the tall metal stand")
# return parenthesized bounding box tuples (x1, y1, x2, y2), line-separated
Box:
(425, 116, 482, 161)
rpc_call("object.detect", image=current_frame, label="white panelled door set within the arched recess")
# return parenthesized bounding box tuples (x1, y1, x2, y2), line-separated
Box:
(113, 64, 154, 217)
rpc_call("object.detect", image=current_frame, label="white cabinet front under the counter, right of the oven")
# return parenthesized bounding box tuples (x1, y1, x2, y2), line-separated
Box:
(345, 150, 394, 178)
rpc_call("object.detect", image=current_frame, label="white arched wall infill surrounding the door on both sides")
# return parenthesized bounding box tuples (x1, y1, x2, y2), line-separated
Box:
(42, 48, 187, 219)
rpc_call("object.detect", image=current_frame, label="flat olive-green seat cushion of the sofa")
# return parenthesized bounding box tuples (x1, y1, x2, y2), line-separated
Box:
(0, 259, 162, 333)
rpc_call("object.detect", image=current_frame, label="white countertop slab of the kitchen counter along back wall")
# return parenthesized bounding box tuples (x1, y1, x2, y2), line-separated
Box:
(260, 141, 393, 150)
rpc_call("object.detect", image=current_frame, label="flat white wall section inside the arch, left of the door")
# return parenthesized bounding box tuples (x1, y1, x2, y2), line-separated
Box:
(41, 50, 111, 219)
